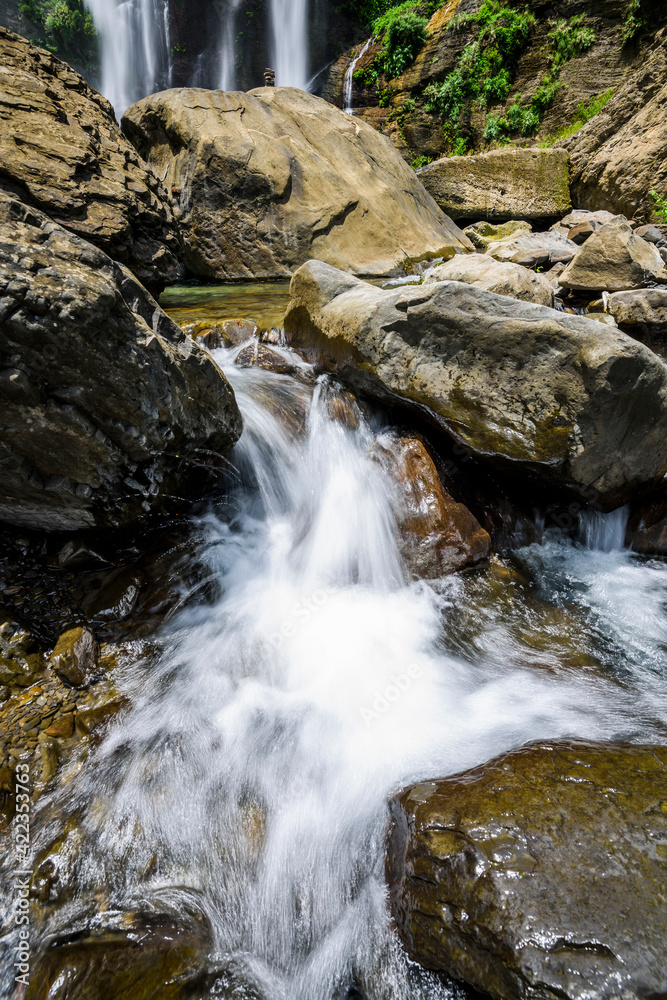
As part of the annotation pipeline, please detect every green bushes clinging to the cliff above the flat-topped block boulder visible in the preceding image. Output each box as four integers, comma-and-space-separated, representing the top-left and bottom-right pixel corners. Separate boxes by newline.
424, 0, 595, 150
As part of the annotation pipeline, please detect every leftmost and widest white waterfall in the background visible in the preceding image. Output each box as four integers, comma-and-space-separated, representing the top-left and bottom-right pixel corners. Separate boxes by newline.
84, 0, 171, 118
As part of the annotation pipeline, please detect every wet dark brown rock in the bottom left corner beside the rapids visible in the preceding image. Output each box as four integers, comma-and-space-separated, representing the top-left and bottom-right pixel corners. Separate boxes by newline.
24, 913, 210, 1000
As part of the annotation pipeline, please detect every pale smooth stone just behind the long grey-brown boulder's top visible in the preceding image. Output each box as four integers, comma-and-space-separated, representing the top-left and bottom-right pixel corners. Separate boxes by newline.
424, 254, 554, 306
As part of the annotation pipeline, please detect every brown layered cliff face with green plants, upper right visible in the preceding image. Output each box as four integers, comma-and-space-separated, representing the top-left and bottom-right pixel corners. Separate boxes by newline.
325, 0, 667, 212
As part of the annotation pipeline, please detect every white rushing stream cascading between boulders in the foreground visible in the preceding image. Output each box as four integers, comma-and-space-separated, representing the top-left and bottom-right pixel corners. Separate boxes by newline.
5, 326, 667, 1000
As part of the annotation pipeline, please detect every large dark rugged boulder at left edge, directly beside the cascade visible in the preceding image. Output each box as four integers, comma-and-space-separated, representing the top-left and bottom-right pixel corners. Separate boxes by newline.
0, 188, 241, 531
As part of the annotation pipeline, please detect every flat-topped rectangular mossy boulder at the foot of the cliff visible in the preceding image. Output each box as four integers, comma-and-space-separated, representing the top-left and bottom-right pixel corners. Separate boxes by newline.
417, 147, 571, 222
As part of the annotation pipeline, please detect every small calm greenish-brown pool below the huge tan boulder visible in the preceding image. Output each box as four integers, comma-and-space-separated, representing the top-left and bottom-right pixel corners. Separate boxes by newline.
160, 281, 289, 332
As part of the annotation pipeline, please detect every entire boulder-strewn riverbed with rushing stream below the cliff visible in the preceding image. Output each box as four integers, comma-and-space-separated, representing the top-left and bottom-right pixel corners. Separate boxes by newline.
0, 13, 667, 1000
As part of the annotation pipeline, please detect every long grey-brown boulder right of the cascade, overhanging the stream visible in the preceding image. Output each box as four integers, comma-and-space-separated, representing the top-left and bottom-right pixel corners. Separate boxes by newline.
285, 261, 667, 509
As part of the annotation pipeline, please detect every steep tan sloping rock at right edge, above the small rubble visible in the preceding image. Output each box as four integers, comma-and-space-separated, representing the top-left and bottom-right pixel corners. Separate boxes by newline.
562, 27, 667, 222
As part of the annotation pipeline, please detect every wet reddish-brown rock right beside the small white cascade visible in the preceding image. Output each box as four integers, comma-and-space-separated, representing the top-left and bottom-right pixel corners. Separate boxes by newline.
376, 437, 491, 580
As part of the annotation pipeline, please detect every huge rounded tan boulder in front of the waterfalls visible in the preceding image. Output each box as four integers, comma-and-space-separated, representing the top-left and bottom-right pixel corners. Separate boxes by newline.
123, 87, 472, 280
